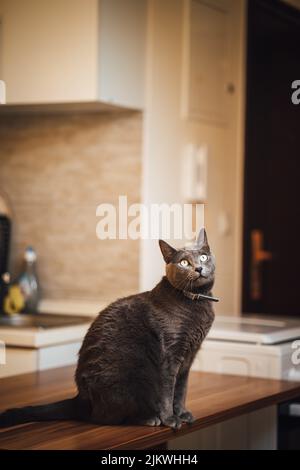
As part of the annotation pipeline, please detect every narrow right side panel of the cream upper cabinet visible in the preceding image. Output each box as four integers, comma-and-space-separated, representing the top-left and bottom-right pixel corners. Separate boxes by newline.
99, 0, 147, 109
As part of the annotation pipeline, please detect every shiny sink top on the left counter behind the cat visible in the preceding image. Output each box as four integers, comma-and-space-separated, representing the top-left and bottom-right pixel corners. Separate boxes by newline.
0, 313, 93, 330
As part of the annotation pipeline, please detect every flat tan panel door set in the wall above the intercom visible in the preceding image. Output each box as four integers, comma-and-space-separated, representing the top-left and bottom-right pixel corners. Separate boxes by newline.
183, 0, 234, 124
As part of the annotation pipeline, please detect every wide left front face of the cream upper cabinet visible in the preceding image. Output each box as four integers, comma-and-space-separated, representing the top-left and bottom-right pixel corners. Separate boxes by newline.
0, 0, 98, 104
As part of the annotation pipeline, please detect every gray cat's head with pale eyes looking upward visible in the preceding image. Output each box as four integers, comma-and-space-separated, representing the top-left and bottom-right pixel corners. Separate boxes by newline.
159, 228, 215, 293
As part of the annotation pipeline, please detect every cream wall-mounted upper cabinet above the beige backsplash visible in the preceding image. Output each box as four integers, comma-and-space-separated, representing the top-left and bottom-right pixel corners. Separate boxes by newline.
0, 0, 147, 109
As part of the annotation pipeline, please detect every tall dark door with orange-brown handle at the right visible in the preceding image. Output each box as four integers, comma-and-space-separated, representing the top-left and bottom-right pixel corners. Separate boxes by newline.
243, 0, 300, 318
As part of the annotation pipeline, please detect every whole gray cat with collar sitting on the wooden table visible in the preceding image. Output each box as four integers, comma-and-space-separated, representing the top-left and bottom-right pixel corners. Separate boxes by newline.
0, 229, 216, 428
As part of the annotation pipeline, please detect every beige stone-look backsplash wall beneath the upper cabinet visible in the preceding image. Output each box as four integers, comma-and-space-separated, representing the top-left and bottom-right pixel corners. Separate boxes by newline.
0, 113, 142, 300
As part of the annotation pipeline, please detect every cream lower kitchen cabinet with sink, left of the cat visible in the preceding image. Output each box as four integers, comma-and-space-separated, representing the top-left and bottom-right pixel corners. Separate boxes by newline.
0, 313, 93, 377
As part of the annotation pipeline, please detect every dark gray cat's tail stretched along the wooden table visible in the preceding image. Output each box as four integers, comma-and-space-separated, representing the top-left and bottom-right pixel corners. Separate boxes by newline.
0, 395, 90, 428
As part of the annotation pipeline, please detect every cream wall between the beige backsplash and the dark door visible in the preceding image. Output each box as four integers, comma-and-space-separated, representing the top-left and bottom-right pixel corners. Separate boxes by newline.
140, 0, 245, 314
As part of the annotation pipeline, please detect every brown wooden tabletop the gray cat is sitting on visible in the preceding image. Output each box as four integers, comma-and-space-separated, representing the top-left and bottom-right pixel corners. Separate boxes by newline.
0, 367, 300, 450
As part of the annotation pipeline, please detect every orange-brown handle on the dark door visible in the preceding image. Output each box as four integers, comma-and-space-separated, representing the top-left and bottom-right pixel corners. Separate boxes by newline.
250, 229, 273, 300
